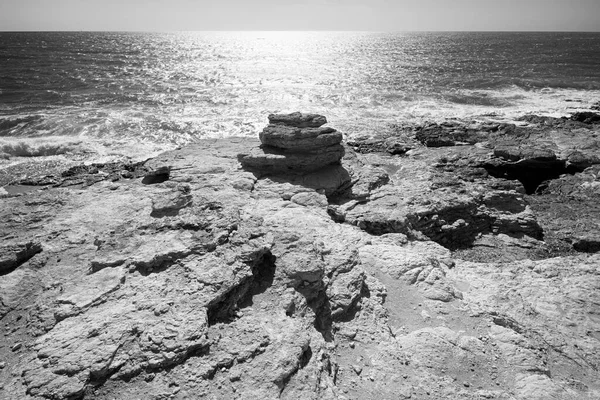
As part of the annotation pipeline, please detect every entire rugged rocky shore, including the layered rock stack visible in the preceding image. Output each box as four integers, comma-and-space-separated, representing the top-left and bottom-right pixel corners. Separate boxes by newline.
0, 113, 600, 400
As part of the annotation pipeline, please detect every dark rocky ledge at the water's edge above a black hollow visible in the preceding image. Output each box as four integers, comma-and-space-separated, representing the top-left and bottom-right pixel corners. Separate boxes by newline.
415, 112, 600, 194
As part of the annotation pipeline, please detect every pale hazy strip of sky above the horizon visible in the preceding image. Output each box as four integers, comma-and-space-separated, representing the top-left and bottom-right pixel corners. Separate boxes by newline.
0, 0, 600, 31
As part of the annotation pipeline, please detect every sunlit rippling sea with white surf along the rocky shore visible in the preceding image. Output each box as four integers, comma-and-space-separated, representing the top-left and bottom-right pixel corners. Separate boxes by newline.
0, 32, 600, 164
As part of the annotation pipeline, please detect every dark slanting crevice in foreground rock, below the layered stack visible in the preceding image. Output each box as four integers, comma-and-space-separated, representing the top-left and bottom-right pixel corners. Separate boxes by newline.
207, 251, 276, 325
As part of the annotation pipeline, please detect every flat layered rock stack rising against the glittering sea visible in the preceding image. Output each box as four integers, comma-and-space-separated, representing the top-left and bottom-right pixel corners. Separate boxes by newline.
238, 112, 344, 174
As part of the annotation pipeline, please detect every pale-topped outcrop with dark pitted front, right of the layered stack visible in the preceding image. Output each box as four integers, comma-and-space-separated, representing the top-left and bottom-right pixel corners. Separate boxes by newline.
329, 148, 543, 250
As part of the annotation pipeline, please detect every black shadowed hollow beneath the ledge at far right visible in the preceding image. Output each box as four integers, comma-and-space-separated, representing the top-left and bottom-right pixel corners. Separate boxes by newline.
483, 160, 583, 194
